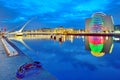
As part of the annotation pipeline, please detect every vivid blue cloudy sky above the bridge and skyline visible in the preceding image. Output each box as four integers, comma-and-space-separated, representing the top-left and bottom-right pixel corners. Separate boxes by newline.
0, 0, 120, 29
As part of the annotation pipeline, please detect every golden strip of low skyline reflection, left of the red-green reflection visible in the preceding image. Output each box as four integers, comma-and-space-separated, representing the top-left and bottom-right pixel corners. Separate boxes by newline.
8, 35, 75, 44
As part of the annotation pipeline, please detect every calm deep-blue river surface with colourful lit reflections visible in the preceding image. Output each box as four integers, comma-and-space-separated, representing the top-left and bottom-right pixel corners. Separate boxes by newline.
11, 36, 120, 80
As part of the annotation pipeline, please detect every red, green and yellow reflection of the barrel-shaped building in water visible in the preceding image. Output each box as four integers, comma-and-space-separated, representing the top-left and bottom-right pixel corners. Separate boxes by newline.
85, 36, 113, 57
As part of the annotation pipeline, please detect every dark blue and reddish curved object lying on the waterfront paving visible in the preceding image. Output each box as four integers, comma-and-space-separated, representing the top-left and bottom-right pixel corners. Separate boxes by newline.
16, 61, 42, 79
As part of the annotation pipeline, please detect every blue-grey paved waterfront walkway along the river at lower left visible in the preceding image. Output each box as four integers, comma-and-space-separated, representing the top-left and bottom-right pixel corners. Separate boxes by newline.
0, 37, 56, 80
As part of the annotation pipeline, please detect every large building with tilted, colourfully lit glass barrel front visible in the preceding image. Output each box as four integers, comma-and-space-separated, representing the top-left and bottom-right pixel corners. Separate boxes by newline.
85, 12, 114, 32
